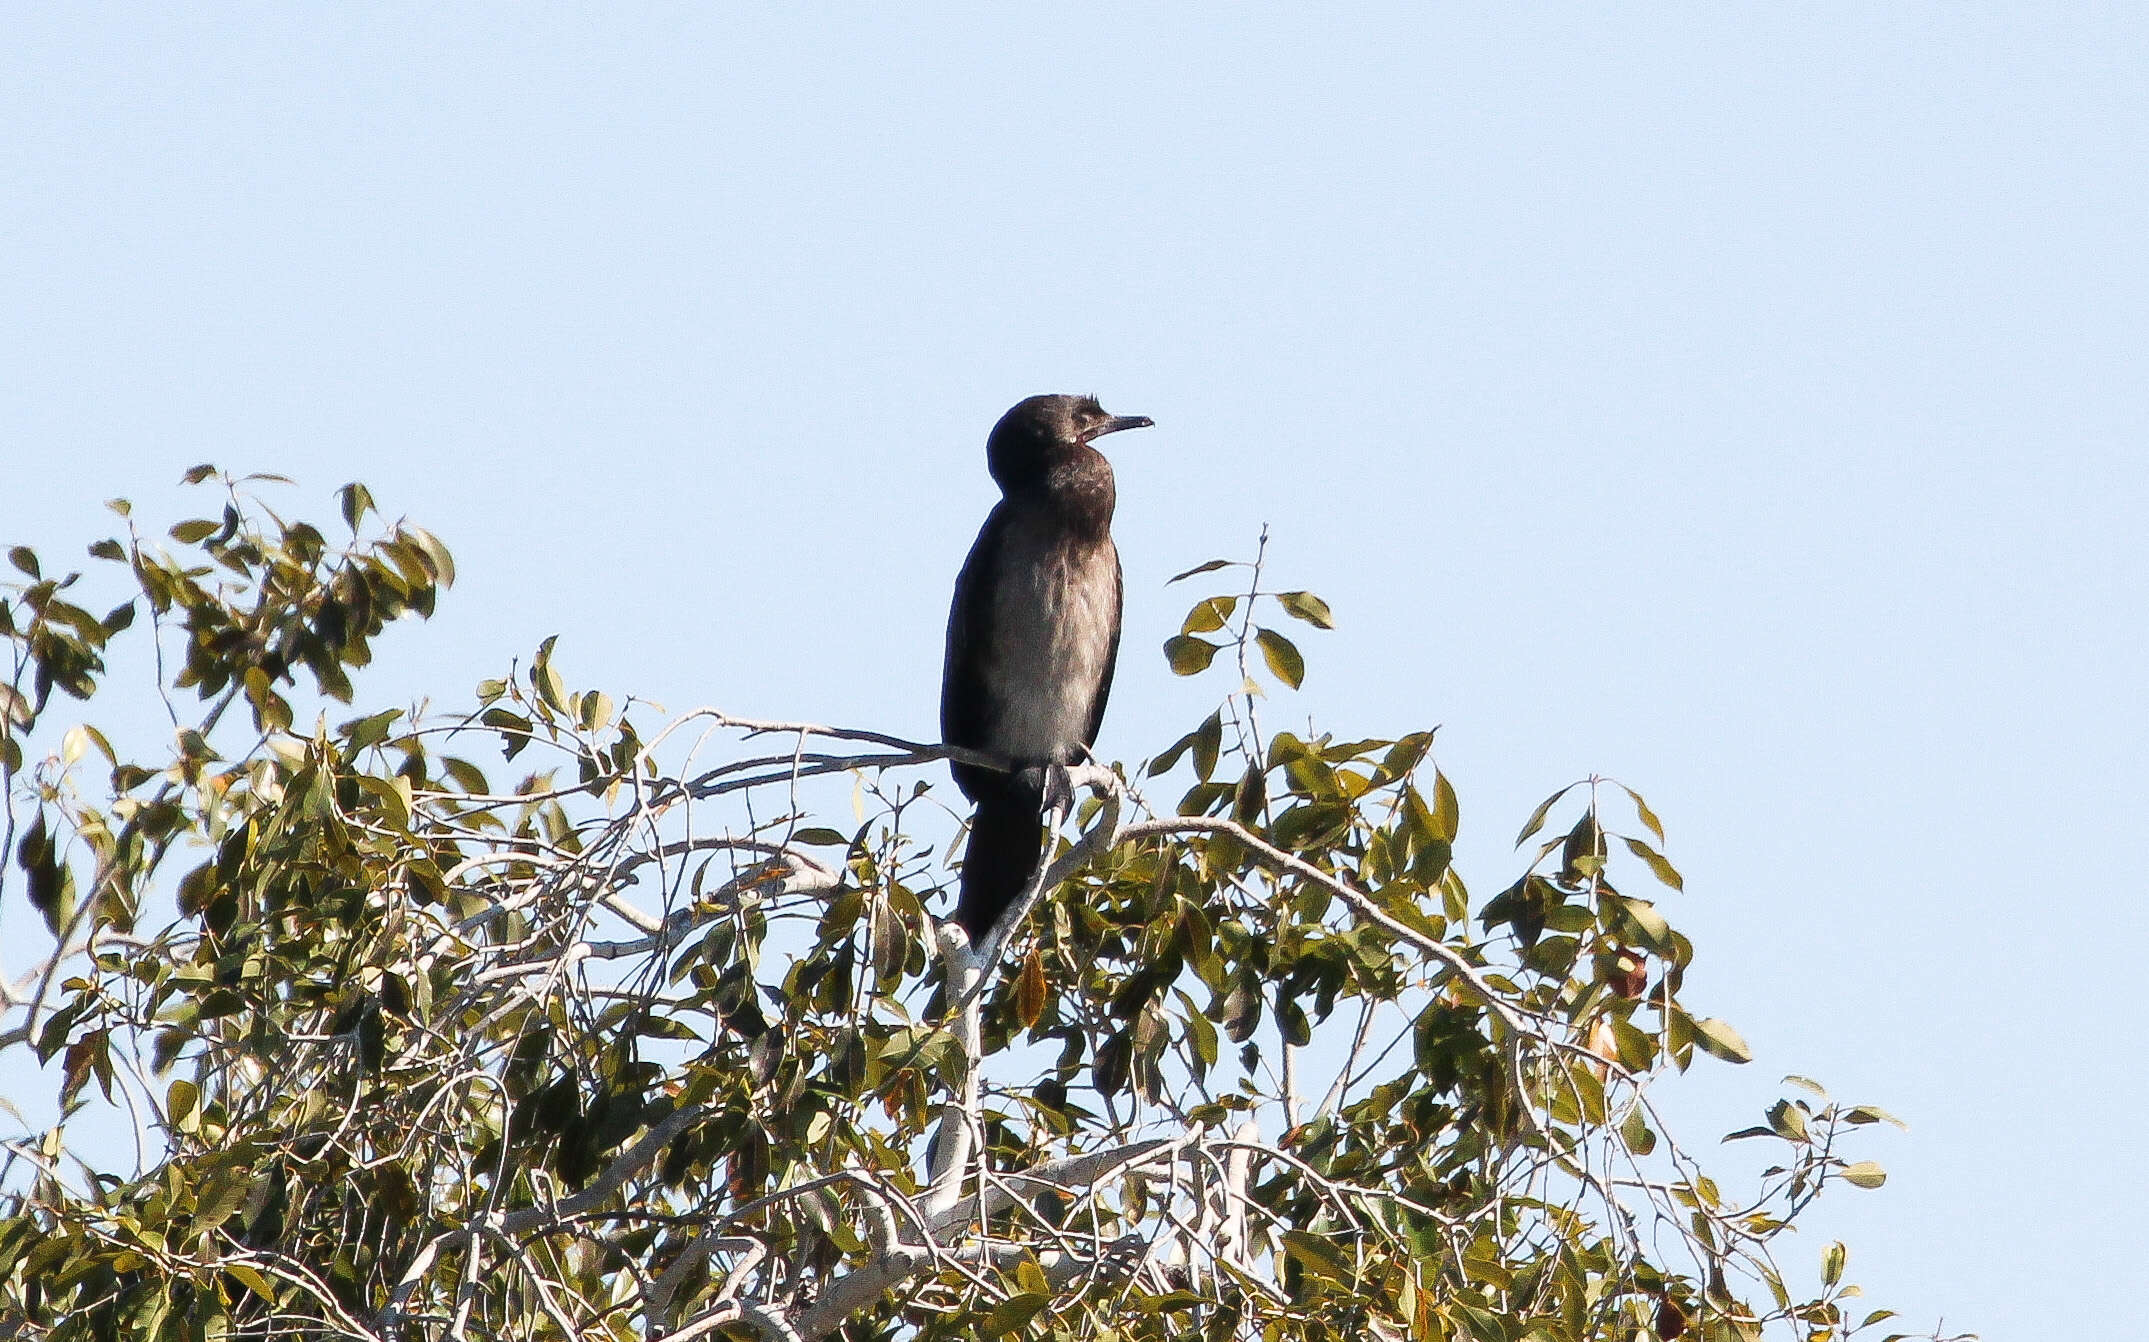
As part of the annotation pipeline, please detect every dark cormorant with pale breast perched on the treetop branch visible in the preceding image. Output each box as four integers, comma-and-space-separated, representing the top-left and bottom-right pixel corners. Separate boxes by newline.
941, 396, 1150, 944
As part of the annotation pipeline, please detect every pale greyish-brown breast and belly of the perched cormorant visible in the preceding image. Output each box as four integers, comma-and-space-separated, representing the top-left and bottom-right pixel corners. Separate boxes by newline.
989, 531, 1120, 761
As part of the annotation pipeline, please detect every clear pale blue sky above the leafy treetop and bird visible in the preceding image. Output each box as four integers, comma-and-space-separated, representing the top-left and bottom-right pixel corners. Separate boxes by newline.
0, 4, 2149, 1338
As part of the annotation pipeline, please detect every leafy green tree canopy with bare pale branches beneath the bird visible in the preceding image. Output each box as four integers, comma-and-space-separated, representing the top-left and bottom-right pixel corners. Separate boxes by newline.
0, 477, 1951, 1342
